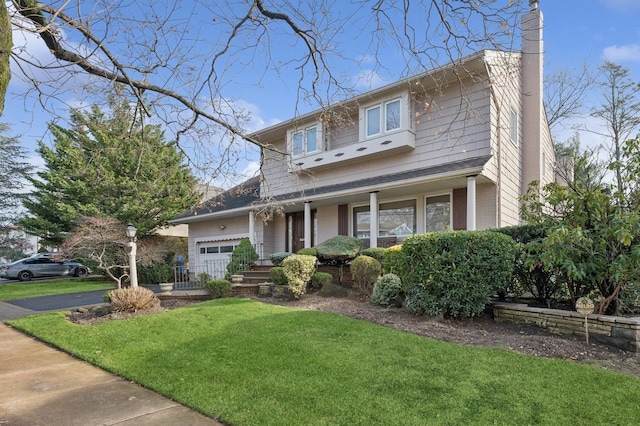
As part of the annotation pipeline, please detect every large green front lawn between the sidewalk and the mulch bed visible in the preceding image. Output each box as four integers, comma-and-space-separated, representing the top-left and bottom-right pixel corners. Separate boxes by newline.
9, 299, 640, 425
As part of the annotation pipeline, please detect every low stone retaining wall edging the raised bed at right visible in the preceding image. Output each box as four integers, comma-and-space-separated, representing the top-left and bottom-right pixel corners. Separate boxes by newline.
492, 302, 640, 353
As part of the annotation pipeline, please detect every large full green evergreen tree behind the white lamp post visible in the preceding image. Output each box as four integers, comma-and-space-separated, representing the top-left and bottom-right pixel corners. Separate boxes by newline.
22, 94, 197, 245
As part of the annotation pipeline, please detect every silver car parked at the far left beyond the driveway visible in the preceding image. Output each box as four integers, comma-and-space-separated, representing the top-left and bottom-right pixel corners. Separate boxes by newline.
0, 254, 91, 281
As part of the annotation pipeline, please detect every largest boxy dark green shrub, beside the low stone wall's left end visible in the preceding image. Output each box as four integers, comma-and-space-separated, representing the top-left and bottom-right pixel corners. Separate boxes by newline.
399, 231, 516, 317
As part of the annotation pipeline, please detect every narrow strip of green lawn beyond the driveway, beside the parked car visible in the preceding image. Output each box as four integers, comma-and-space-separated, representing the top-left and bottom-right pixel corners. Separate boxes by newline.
0, 278, 115, 300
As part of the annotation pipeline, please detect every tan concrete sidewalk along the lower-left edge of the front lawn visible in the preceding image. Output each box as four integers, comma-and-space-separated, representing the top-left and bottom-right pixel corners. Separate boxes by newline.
0, 322, 221, 426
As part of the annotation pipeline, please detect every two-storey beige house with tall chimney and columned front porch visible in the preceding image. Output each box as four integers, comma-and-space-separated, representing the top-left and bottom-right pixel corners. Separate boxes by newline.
173, 2, 555, 278
